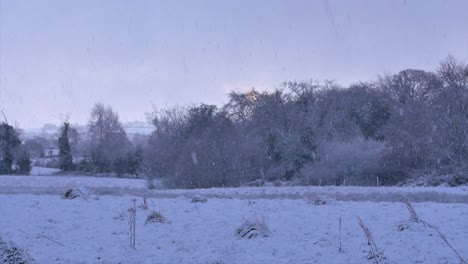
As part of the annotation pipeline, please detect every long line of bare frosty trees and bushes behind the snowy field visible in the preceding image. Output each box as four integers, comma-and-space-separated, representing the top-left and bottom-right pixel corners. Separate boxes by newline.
1, 57, 468, 188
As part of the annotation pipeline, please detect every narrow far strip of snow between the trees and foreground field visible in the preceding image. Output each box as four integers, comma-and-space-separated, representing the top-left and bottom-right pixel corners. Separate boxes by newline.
0, 176, 468, 203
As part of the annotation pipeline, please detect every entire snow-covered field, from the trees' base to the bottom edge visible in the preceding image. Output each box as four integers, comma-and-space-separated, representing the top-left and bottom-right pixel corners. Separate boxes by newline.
0, 176, 468, 263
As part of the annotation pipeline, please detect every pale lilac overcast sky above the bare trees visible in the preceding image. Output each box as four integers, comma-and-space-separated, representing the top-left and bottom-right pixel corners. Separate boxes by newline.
0, 0, 468, 128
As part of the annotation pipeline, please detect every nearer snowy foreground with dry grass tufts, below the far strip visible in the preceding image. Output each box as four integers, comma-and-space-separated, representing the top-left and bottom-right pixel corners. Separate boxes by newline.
0, 195, 468, 263
